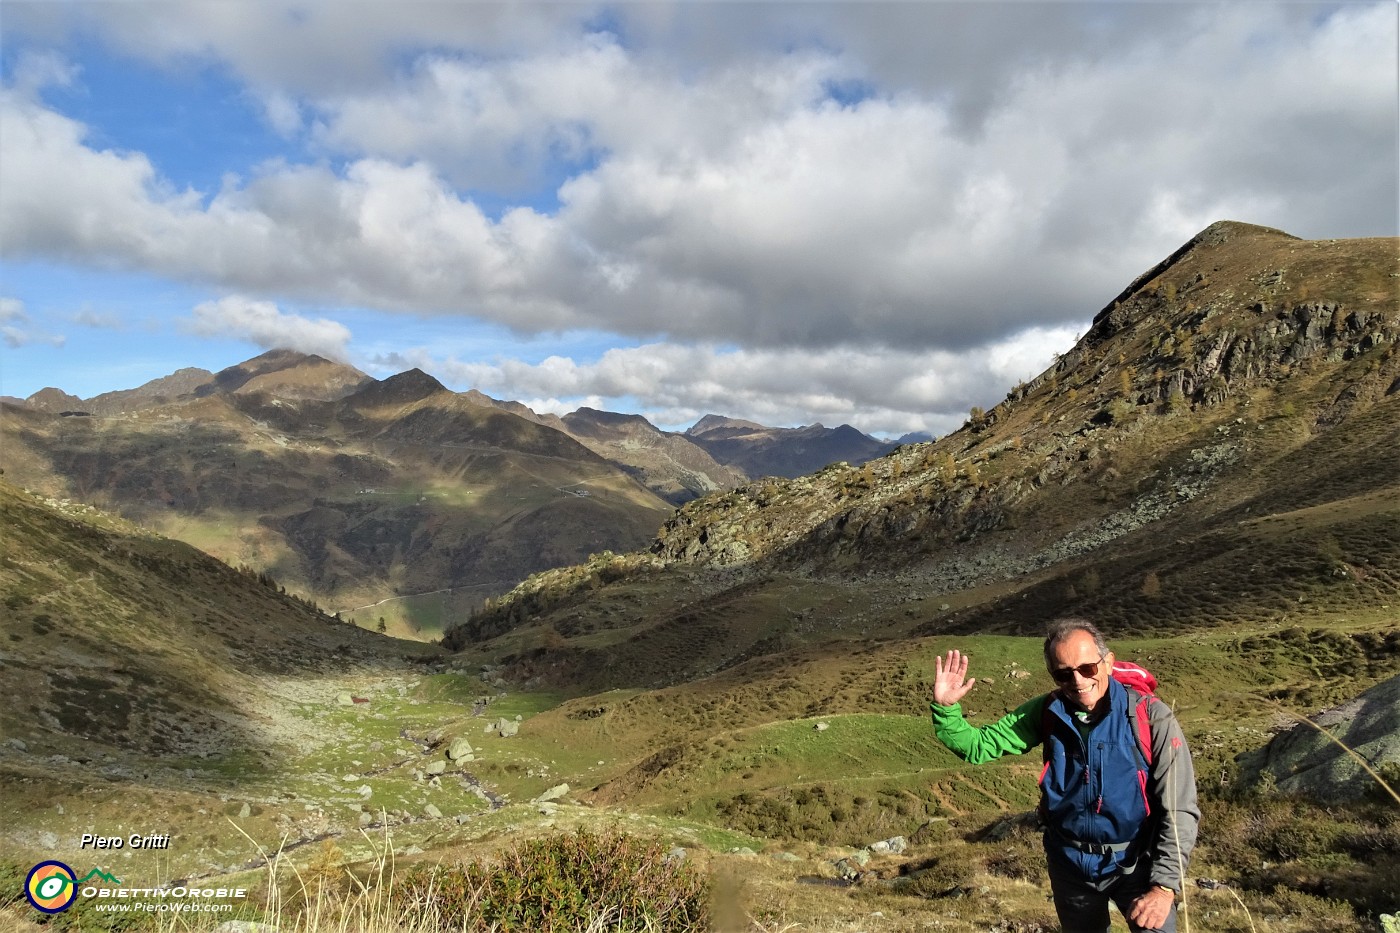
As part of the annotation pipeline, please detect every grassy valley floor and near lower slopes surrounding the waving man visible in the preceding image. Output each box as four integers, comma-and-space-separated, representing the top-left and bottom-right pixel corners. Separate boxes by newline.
0, 486, 1400, 933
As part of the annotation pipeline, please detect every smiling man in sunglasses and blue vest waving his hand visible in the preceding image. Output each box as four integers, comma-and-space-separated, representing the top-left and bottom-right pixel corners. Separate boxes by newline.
930, 619, 1201, 933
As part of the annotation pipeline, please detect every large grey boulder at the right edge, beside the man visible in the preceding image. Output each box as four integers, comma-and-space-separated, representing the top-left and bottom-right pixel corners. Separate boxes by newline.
1238, 675, 1400, 803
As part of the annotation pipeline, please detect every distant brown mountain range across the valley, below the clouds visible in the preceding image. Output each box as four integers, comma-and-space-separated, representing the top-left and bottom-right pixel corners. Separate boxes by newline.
0, 350, 890, 636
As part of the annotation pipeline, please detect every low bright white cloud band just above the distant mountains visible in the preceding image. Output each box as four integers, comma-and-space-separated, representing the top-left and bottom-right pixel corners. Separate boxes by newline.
372, 328, 1075, 434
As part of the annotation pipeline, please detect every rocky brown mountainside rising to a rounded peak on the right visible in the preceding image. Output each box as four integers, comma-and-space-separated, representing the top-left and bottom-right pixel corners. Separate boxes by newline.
447, 221, 1400, 680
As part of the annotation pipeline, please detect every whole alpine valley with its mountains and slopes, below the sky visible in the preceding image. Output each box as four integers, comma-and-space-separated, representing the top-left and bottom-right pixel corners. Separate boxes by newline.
0, 221, 1400, 933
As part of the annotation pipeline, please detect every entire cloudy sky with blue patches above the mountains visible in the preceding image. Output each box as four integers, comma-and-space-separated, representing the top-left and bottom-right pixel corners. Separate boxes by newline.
0, 0, 1400, 437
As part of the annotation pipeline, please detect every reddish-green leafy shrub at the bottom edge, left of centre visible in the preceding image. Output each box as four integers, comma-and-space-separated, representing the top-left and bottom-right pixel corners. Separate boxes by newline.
395, 829, 710, 933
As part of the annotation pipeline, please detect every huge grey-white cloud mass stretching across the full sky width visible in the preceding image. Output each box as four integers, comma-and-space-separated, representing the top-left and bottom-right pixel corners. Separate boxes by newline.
0, 6, 1396, 357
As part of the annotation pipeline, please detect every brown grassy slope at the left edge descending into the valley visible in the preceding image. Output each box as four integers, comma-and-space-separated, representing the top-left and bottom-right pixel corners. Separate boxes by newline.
0, 481, 431, 765
